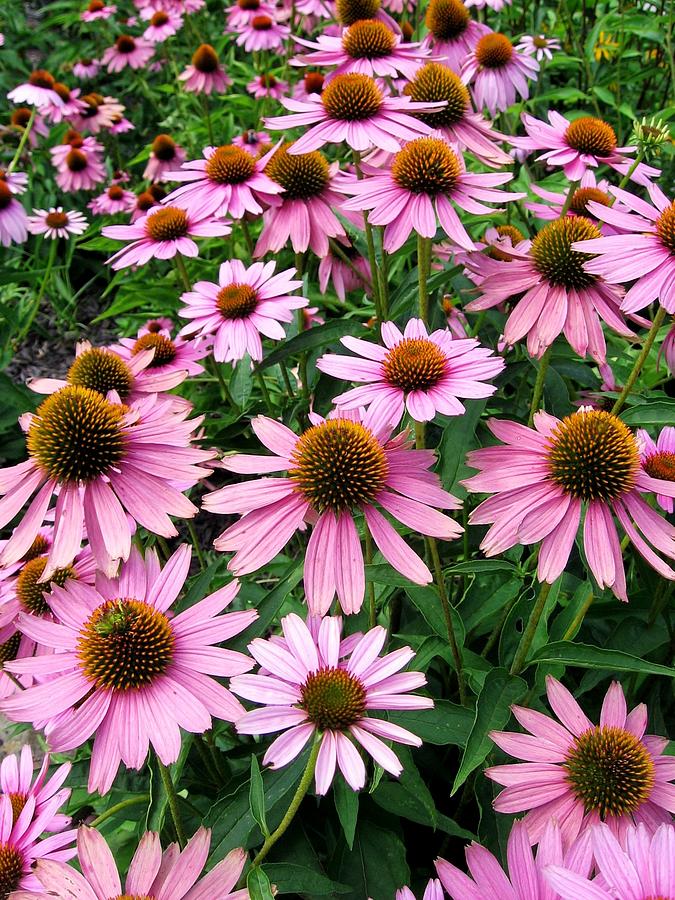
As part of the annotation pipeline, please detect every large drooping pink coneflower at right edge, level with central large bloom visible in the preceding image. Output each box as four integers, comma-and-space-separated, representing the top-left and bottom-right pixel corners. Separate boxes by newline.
463, 407, 675, 600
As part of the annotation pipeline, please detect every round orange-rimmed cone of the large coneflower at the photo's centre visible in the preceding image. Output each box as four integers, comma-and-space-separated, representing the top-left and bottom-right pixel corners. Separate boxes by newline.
288, 419, 389, 514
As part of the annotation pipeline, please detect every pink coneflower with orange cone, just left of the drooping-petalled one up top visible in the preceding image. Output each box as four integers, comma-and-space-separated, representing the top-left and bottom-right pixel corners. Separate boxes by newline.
163, 144, 283, 219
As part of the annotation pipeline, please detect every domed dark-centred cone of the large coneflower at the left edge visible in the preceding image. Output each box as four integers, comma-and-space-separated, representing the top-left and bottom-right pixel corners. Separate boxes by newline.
26, 385, 126, 484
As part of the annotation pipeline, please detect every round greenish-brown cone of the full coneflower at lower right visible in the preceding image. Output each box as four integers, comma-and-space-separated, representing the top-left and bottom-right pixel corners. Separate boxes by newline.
563, 725, 655, 819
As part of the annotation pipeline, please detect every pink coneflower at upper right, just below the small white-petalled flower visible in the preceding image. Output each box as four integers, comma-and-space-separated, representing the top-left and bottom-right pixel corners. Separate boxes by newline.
510, 110, 661, 186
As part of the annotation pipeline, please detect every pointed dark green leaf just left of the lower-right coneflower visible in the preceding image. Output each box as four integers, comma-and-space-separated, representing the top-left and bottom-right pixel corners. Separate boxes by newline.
450, 669, 527, 795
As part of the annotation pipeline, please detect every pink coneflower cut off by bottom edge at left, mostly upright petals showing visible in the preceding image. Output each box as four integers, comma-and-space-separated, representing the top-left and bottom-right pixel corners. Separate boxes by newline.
26, 826, 248, 900
